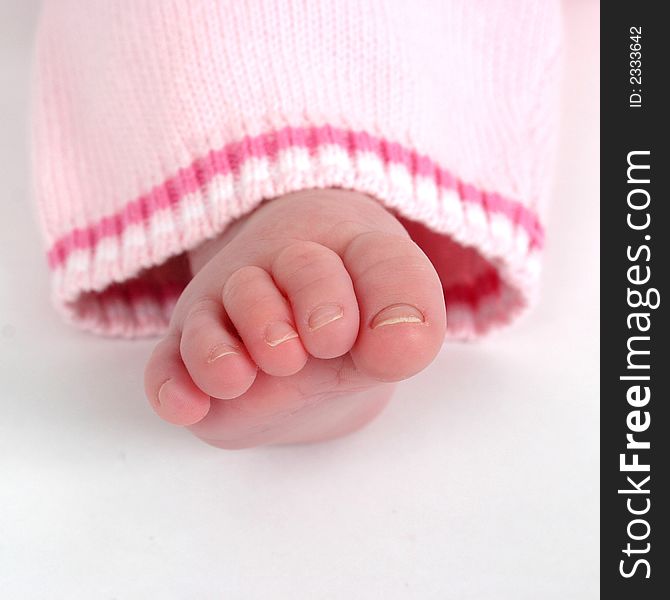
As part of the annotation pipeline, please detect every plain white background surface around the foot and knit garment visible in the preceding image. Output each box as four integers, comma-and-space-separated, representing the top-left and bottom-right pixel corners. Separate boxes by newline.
0, 0, 599, 600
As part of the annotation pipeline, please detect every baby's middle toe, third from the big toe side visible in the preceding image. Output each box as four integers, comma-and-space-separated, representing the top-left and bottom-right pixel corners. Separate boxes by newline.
223, 266, 307, 376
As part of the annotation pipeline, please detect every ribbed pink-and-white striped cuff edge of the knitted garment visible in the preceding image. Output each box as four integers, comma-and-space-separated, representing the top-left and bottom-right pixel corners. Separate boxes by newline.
48, 126, 544, 338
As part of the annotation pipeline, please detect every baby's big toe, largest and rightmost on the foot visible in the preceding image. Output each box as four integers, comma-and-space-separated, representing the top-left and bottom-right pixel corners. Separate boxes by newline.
343, 232, 446, 381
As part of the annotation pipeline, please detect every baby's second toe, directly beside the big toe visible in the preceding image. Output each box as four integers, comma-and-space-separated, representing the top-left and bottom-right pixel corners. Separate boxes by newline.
272, 242, 359, 359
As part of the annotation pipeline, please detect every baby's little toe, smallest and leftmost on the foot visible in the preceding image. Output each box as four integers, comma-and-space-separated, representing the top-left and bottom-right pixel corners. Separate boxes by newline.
144, 333, 210, 425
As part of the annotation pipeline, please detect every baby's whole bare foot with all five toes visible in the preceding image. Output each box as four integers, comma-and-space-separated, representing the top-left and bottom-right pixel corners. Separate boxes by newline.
145, 189, 446, 448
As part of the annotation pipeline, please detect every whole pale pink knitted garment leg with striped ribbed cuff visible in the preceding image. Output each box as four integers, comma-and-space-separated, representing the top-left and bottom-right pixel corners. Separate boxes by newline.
33, 0, 561, 338
